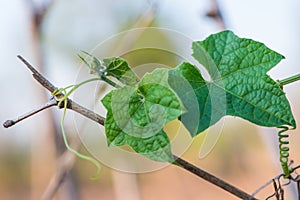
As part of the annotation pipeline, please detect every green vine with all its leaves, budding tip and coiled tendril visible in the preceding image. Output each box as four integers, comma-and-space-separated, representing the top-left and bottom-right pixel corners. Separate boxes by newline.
75, 31, 296, 177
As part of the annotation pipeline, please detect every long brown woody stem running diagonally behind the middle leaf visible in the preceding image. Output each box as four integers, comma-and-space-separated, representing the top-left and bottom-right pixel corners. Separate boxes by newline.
3, 55, 256, 200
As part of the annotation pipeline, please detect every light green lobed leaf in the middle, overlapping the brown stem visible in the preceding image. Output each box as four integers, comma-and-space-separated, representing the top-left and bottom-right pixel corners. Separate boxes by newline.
102, 69, 184, 162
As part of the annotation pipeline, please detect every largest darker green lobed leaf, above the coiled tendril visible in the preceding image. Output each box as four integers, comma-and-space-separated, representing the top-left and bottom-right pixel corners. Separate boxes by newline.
169, 31, 296, 136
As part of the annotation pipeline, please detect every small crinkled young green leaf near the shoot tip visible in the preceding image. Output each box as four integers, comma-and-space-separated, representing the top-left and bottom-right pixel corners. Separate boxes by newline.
103, 57, 139, 86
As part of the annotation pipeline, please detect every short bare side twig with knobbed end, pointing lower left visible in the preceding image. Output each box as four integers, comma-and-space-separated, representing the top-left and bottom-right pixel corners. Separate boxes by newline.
3, 98, 57, 128
